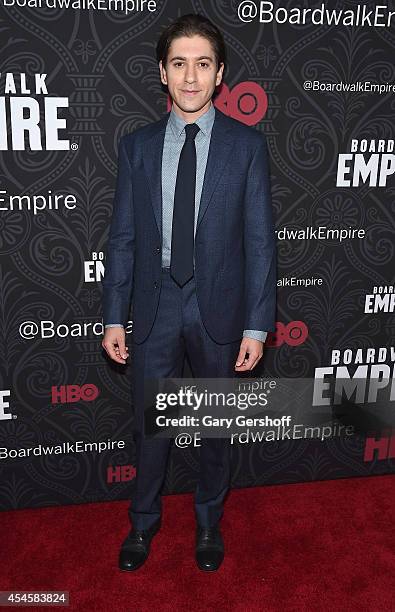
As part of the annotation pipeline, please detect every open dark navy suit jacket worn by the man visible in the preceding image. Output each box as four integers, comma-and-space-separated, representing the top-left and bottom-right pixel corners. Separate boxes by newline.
102, 108, 277, 344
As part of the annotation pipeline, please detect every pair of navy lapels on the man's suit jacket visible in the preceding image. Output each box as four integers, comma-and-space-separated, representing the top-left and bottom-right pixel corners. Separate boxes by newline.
143, 108, 232, 240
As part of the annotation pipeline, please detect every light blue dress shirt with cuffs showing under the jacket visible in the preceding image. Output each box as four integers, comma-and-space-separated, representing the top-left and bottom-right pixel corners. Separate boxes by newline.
106, 103, 267, 342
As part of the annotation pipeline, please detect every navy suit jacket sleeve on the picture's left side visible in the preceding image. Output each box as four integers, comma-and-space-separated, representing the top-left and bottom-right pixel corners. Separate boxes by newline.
102, 136, 135, 325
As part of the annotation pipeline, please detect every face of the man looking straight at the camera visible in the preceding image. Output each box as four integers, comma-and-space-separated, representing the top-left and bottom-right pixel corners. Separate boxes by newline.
159, 35, 224, 121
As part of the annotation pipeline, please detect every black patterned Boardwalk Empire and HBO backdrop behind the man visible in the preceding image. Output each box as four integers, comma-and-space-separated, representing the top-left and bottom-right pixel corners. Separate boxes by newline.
0, 0, 395, 510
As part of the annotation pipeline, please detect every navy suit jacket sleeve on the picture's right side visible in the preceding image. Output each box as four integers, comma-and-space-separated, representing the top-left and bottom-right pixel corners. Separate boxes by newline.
244, 134, 277, 331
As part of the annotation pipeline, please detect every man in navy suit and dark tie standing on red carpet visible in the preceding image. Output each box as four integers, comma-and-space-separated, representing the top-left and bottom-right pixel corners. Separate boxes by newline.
102, 15, 276, 571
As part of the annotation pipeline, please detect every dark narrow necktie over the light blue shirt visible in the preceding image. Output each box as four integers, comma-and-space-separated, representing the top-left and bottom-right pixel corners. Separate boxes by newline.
170, 123, 200, 287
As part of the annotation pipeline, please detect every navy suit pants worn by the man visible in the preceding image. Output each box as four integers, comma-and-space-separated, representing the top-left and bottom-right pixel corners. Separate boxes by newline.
129, 268, 242, 529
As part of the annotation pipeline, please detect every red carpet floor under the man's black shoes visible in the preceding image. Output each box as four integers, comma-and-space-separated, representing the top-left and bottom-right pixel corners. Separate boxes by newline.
0, 476, 395, 612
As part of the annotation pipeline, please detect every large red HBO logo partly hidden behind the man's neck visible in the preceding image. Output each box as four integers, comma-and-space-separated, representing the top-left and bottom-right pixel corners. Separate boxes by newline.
167, 81, 268, 125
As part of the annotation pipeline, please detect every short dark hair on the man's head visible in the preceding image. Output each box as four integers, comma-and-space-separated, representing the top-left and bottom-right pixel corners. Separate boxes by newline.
156, 13, 226, 72
